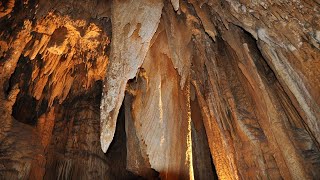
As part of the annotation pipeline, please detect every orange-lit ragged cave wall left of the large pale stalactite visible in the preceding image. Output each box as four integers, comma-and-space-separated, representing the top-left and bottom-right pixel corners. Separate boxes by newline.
0, 1, 111, 179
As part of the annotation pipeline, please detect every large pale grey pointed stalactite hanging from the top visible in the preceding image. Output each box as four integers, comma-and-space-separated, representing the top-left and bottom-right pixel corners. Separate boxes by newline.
100, 0, 163, 152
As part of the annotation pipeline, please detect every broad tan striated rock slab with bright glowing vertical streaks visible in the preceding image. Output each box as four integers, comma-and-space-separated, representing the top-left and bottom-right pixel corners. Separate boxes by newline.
128, 21, 193, 179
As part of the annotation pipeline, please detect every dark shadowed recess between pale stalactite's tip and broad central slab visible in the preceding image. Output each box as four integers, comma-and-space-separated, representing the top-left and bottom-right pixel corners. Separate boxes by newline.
105, 90, 160, 179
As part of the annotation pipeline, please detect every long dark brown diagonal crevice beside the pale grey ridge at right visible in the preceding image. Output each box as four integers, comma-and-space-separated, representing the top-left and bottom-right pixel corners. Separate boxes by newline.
232, 26, 320, 170
